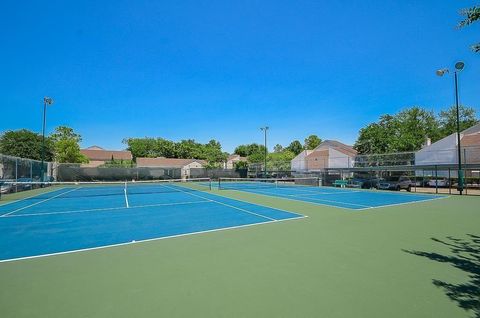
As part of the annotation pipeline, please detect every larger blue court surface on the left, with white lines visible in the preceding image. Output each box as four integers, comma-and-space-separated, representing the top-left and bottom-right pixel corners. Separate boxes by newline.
0, 185, 303, 261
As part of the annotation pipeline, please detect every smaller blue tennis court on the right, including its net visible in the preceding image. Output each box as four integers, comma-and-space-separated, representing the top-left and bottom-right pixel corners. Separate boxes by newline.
218, 178, 447, 210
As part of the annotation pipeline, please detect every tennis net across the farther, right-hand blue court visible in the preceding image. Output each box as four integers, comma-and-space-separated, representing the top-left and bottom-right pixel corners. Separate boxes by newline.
218, 177, 320, 190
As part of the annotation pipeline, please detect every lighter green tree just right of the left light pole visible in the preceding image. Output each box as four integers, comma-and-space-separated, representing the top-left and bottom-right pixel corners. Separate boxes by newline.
49, 126, 88, 163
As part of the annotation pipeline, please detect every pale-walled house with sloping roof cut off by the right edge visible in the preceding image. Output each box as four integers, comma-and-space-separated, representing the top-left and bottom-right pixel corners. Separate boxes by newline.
415, 123, 480, 166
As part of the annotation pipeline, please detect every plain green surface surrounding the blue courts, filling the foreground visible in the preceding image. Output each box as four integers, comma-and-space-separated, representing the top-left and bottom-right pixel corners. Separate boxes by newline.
0, 190, 480, 318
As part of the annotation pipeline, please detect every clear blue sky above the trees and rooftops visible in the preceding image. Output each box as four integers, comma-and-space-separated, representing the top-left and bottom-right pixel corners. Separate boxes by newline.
0, 0, 480, 151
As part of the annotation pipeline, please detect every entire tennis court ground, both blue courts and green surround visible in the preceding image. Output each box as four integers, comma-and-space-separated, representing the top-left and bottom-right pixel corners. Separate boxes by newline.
0, 179, 479, 318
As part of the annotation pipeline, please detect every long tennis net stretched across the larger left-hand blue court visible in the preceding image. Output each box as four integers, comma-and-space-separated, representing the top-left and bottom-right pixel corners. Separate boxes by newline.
0, 178, 211, 199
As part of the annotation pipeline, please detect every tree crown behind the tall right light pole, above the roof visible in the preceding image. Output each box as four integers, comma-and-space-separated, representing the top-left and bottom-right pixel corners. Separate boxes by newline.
438, 105, 479, 138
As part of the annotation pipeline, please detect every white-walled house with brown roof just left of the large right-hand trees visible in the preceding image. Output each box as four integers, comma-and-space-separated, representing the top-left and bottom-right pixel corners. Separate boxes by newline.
291, 140, 357, 171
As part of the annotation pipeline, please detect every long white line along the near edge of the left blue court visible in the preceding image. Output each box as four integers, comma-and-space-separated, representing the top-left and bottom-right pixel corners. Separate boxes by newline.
0, 216, 304, 263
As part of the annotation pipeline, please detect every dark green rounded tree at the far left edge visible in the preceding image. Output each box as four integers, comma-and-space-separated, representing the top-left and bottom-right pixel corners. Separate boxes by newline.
0, 129, 54, 161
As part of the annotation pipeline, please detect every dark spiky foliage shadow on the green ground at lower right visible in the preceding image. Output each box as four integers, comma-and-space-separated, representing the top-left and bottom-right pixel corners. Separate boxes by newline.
403, 234, 480, 318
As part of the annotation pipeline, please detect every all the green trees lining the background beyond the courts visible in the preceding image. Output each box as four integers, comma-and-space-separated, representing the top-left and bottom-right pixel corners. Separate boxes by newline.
0, 106, 479, 165
